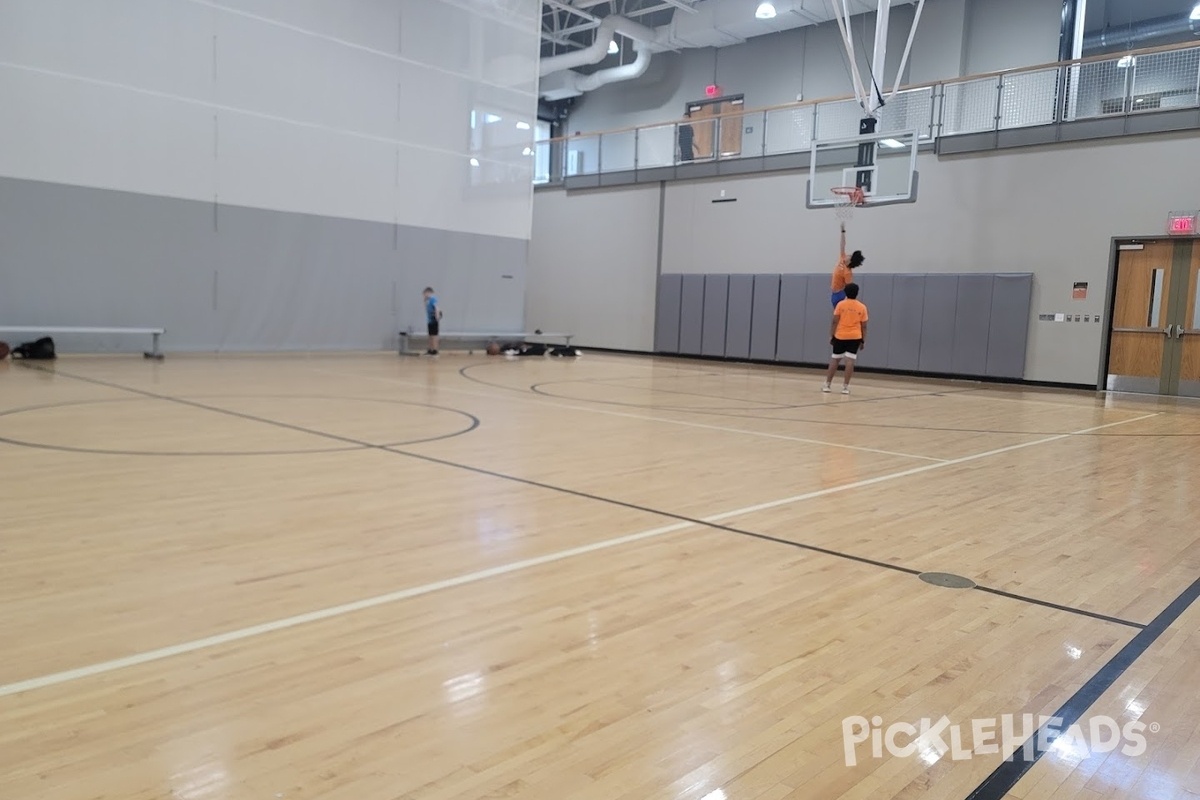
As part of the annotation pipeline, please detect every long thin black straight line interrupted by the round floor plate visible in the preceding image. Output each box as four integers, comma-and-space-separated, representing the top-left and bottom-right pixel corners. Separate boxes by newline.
16, 366, 1145, 628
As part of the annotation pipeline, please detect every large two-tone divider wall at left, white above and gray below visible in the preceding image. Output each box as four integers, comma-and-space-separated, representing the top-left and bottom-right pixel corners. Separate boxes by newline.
0, 0, 539, 349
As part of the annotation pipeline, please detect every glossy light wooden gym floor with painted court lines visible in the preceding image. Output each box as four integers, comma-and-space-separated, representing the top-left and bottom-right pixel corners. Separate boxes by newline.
0, 354, 1200, 800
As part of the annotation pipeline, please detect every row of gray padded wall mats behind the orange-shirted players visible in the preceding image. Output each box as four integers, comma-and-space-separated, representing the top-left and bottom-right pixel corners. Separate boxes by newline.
655, 272, 1033, 378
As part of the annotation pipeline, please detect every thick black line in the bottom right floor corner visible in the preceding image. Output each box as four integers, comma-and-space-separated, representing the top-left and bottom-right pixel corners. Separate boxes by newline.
966, 578, 1200, 800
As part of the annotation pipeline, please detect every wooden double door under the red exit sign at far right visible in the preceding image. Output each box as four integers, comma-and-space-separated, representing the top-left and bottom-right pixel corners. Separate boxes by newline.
1108, 239, 1200, 397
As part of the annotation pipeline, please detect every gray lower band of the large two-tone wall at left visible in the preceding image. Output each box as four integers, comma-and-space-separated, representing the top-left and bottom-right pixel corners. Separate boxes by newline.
0, 179, 528, 351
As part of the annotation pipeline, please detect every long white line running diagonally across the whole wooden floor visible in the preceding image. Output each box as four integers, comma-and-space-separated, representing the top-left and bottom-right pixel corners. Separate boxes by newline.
0, 413, 1159, 697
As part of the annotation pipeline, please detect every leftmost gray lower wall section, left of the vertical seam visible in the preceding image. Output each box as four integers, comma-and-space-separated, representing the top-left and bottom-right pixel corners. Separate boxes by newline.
0, 179, 217, 353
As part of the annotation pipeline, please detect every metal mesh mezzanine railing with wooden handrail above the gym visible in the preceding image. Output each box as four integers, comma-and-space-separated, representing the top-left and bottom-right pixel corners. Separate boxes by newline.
534, 43, 1200, 184
